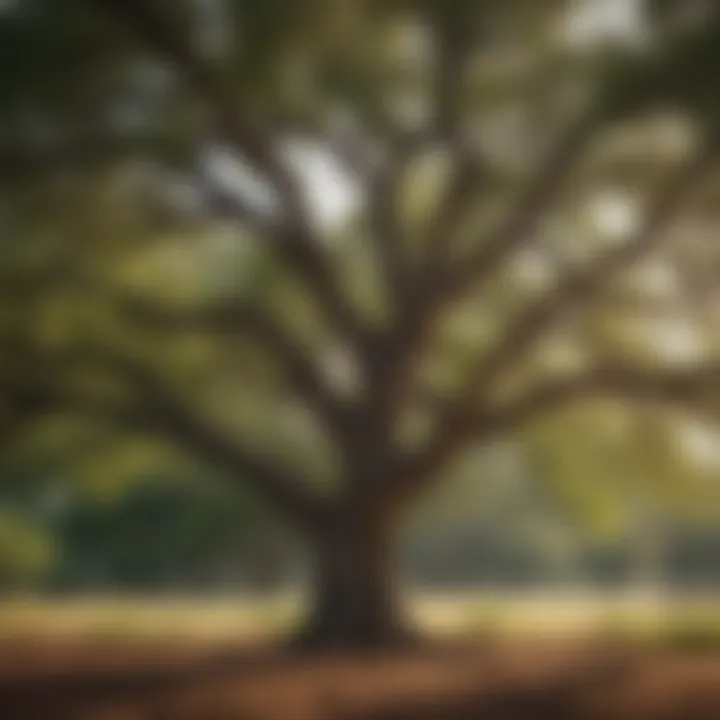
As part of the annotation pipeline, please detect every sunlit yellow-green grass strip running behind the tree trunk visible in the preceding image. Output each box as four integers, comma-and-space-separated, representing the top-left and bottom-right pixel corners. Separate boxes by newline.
0, 592, 720, 649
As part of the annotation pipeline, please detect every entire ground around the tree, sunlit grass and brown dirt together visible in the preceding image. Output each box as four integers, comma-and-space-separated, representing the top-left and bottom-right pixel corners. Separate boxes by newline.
0, 593, 720, 720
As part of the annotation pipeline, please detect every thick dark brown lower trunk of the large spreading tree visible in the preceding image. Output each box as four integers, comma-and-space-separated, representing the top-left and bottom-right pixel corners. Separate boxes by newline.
299, 506, 409, 649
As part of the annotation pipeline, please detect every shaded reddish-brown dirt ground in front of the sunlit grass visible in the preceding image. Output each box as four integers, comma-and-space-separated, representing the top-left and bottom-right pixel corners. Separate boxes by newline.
0, 638, 720, 720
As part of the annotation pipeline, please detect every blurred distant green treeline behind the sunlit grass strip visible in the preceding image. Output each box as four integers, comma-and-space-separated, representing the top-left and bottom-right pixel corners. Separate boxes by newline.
0, 483, 720, 592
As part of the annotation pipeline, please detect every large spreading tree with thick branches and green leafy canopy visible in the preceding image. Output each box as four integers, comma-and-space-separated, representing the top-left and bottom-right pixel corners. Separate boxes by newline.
2, 0, 720, 646
